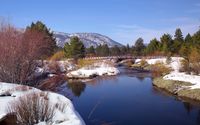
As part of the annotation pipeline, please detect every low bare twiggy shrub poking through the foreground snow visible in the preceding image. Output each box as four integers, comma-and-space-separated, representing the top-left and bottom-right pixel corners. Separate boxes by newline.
7, 92, 55, 125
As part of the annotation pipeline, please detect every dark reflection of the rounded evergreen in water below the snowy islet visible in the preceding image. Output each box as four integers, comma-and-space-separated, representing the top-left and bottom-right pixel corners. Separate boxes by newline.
67, 81, 86, 97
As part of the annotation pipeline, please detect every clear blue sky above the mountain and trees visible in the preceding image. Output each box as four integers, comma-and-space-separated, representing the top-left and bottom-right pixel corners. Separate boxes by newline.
0, 0, 200, 45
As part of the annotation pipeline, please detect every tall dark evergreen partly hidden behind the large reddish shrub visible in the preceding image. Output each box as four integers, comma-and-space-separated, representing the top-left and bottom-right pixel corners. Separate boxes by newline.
25, 21, 57, 56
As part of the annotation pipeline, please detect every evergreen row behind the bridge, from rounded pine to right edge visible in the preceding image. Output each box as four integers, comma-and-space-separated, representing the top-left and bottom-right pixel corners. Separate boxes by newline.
64, 28, 200, 58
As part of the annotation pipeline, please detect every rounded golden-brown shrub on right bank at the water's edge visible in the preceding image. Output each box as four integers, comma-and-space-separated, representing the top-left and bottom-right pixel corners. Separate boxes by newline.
151, 62, 172, 77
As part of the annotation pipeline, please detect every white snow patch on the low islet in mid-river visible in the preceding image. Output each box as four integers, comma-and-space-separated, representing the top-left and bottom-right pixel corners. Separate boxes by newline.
67, 62, 119, 78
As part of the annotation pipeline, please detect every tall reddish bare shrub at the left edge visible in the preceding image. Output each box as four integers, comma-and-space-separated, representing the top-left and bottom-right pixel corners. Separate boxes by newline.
0, 23, 52, 84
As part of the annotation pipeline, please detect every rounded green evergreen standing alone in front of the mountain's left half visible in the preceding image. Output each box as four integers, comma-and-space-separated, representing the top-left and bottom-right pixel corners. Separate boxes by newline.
64, 37, 85, 59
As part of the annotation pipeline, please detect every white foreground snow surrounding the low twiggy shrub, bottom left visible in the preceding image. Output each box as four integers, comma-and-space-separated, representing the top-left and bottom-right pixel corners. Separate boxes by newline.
0, 82, 85, 125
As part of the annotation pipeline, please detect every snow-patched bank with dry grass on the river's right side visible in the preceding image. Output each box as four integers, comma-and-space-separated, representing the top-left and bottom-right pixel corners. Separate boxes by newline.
136, 57, 200, 101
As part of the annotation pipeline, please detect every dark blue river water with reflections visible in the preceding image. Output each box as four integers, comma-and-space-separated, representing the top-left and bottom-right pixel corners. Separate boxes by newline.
55, 69, 200, 125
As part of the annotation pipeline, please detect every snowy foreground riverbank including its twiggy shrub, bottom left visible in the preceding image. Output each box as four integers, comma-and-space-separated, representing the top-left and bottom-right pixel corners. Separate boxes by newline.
0, 82, 85, 125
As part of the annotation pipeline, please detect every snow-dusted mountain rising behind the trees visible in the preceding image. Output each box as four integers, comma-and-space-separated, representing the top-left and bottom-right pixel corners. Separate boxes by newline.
54, 32, 123, 48
